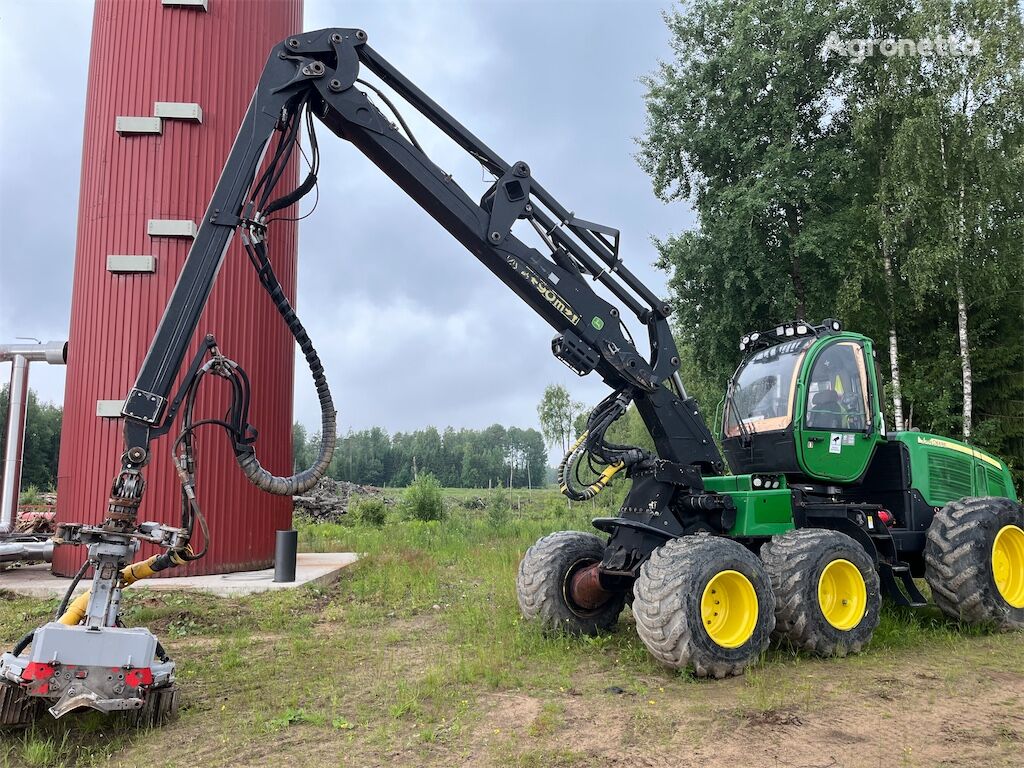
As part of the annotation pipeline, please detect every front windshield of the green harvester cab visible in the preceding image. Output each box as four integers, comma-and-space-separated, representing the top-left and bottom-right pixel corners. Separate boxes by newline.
725, 337, 814, 437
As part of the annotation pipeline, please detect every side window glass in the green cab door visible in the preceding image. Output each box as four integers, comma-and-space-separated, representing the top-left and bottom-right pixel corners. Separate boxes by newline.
805, 341, 867, 432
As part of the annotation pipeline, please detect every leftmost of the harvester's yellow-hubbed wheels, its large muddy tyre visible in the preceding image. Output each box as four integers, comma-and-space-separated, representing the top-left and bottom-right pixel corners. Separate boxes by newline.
633, 536, 775, 678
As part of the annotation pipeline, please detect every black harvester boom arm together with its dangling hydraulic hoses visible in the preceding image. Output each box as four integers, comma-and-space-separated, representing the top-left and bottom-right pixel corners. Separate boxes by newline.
96, 29, 722, 581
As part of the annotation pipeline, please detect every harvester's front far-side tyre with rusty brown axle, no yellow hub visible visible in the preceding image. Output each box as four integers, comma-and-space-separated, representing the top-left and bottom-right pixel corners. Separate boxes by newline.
515, 530, 626, 635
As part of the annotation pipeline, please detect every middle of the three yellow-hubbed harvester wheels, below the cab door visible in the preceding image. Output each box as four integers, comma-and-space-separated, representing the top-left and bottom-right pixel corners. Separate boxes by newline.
761, 528, 882, 656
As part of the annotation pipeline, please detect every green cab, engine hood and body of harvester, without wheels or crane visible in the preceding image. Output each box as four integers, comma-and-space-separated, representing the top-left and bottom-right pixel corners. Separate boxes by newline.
705, 319, 1017, 604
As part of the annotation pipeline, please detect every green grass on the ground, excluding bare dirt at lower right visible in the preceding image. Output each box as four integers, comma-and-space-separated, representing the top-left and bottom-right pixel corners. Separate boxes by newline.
0, 489, 1024, 766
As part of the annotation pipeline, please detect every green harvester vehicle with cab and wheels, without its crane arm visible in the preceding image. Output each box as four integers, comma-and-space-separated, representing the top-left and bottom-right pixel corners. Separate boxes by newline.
518, 319, 1024, 677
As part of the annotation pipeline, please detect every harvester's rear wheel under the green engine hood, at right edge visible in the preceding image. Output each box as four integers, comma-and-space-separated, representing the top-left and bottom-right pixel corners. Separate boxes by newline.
925, 497, 1024, 630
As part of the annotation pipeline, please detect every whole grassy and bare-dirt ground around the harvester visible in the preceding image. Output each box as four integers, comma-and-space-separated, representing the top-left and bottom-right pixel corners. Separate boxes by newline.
0, 489, 1024, 768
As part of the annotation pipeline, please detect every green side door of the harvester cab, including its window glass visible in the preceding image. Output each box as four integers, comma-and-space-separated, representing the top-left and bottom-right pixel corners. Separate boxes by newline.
794, 338, 881, 482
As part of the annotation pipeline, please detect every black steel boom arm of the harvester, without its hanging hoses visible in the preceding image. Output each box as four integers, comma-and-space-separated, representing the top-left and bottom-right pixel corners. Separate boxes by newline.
124, 29, 720, 468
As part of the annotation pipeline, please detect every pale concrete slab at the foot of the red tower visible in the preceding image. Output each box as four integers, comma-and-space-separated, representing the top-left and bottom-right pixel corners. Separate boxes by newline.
0, 552, 357, 597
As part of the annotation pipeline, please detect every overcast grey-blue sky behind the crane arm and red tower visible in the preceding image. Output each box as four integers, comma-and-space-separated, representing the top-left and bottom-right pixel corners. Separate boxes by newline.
0, 0, 693, 442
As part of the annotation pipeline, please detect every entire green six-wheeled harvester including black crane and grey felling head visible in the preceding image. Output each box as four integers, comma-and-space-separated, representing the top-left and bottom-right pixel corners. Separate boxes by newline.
0, 29, 1024, 725
